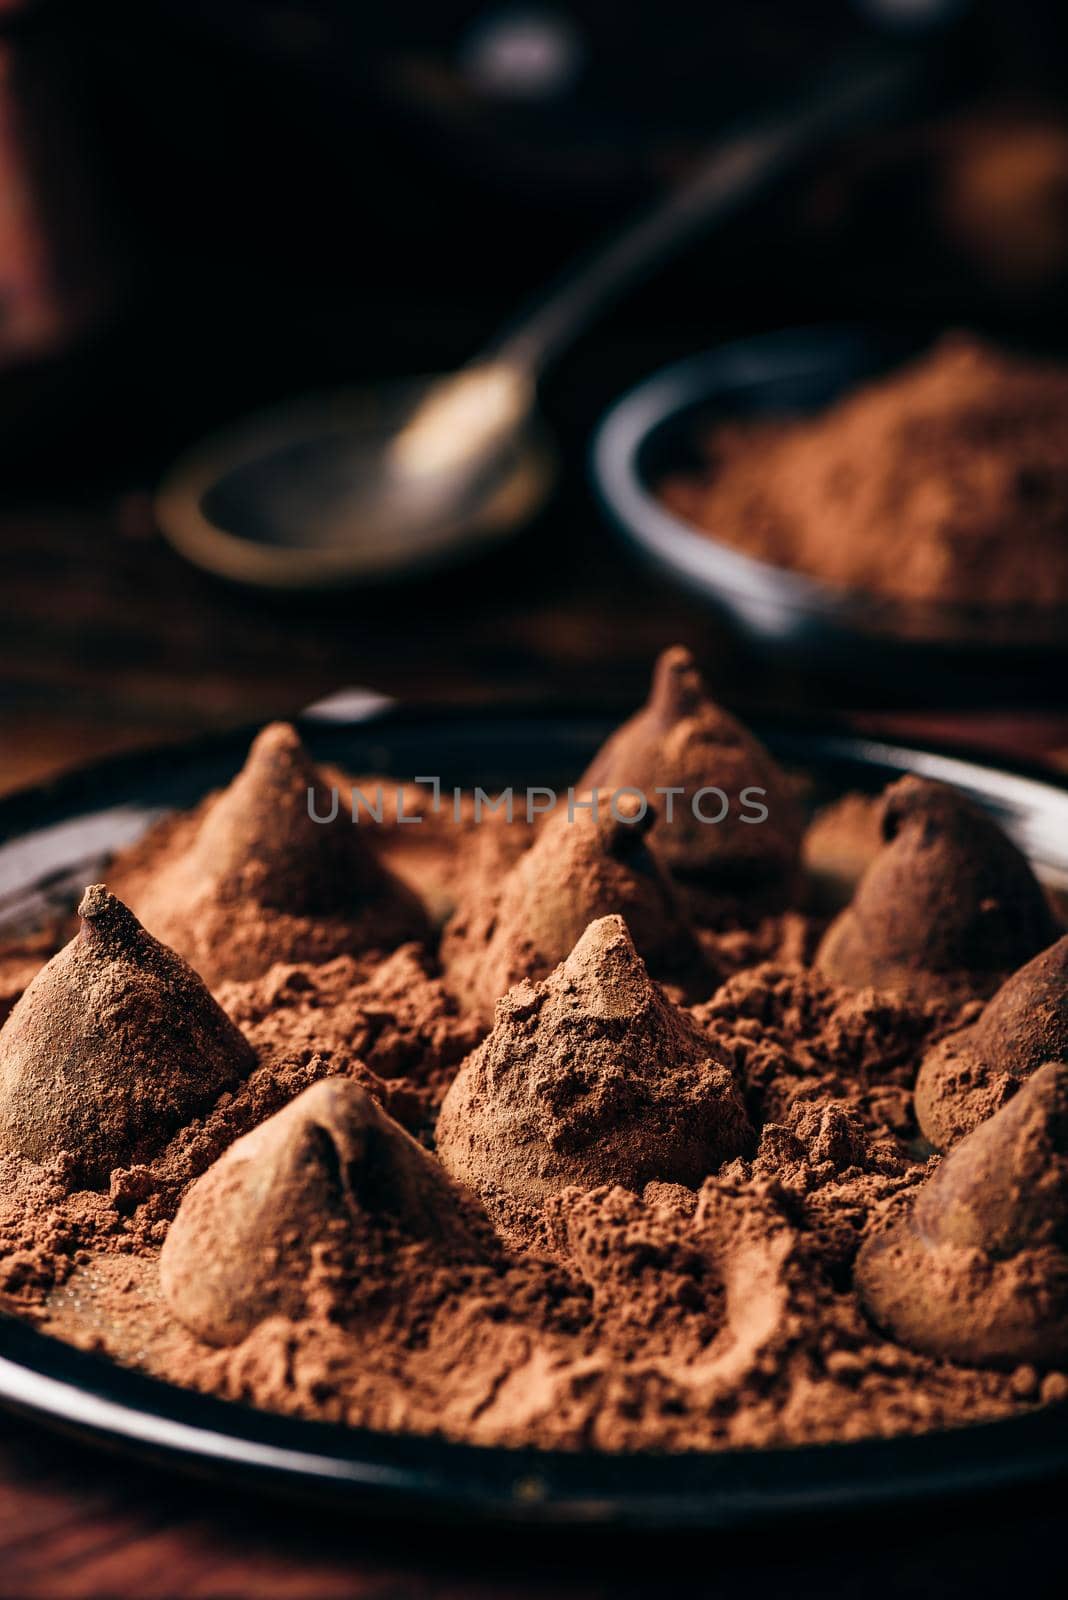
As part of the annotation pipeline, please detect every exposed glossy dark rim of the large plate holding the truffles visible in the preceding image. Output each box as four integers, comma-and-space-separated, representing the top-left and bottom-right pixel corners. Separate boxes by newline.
0, 709, 1068, 1528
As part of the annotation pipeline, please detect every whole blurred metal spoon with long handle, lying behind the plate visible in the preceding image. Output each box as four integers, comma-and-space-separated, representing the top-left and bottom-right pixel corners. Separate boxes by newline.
157, 51, 916, 587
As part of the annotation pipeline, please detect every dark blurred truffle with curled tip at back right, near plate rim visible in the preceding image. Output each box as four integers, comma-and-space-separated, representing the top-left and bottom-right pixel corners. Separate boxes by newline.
815, 778, 1058, 1000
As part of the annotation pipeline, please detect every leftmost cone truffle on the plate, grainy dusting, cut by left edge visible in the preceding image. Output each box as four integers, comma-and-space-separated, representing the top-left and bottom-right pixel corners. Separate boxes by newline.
0, 883, 256, 1184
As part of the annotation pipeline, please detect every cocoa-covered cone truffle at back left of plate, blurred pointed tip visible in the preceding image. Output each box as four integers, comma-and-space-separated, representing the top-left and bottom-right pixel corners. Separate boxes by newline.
123, 723, 427, 984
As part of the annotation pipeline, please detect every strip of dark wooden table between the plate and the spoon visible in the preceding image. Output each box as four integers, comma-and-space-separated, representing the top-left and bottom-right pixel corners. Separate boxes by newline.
0, 499, 1068, 794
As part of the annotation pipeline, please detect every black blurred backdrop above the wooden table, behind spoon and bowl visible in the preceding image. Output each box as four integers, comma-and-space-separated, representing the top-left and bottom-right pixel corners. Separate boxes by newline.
8, 0, 1068, 490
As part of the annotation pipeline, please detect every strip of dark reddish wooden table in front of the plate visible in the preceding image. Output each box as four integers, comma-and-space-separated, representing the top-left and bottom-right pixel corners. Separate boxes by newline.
0, 1419, 1065, 1600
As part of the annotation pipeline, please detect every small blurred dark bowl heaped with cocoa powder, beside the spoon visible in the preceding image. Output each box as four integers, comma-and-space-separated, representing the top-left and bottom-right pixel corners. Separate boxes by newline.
593, 328, 1068, 666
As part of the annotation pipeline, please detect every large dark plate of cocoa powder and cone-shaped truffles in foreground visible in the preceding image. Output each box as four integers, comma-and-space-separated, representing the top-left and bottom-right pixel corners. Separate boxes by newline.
0, 650, 1068, 1526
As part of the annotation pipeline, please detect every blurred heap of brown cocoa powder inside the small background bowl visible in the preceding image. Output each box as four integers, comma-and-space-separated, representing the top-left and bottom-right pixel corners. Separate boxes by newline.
660, 334, 1068, 610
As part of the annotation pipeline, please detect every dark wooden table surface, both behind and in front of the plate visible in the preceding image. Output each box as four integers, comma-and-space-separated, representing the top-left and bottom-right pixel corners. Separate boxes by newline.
0, 502, 1068, 1600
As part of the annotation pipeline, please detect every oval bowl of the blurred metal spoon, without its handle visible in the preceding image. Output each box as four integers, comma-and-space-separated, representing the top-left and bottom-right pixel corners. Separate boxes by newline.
157, 376, 556, 589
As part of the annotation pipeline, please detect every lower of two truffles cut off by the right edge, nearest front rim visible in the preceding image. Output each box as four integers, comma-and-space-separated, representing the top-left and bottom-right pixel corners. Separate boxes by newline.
855, 1062, 1068, 1366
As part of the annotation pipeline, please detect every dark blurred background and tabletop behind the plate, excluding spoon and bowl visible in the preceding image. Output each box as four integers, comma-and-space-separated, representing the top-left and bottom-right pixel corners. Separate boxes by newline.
0, 0, 1068, 787
